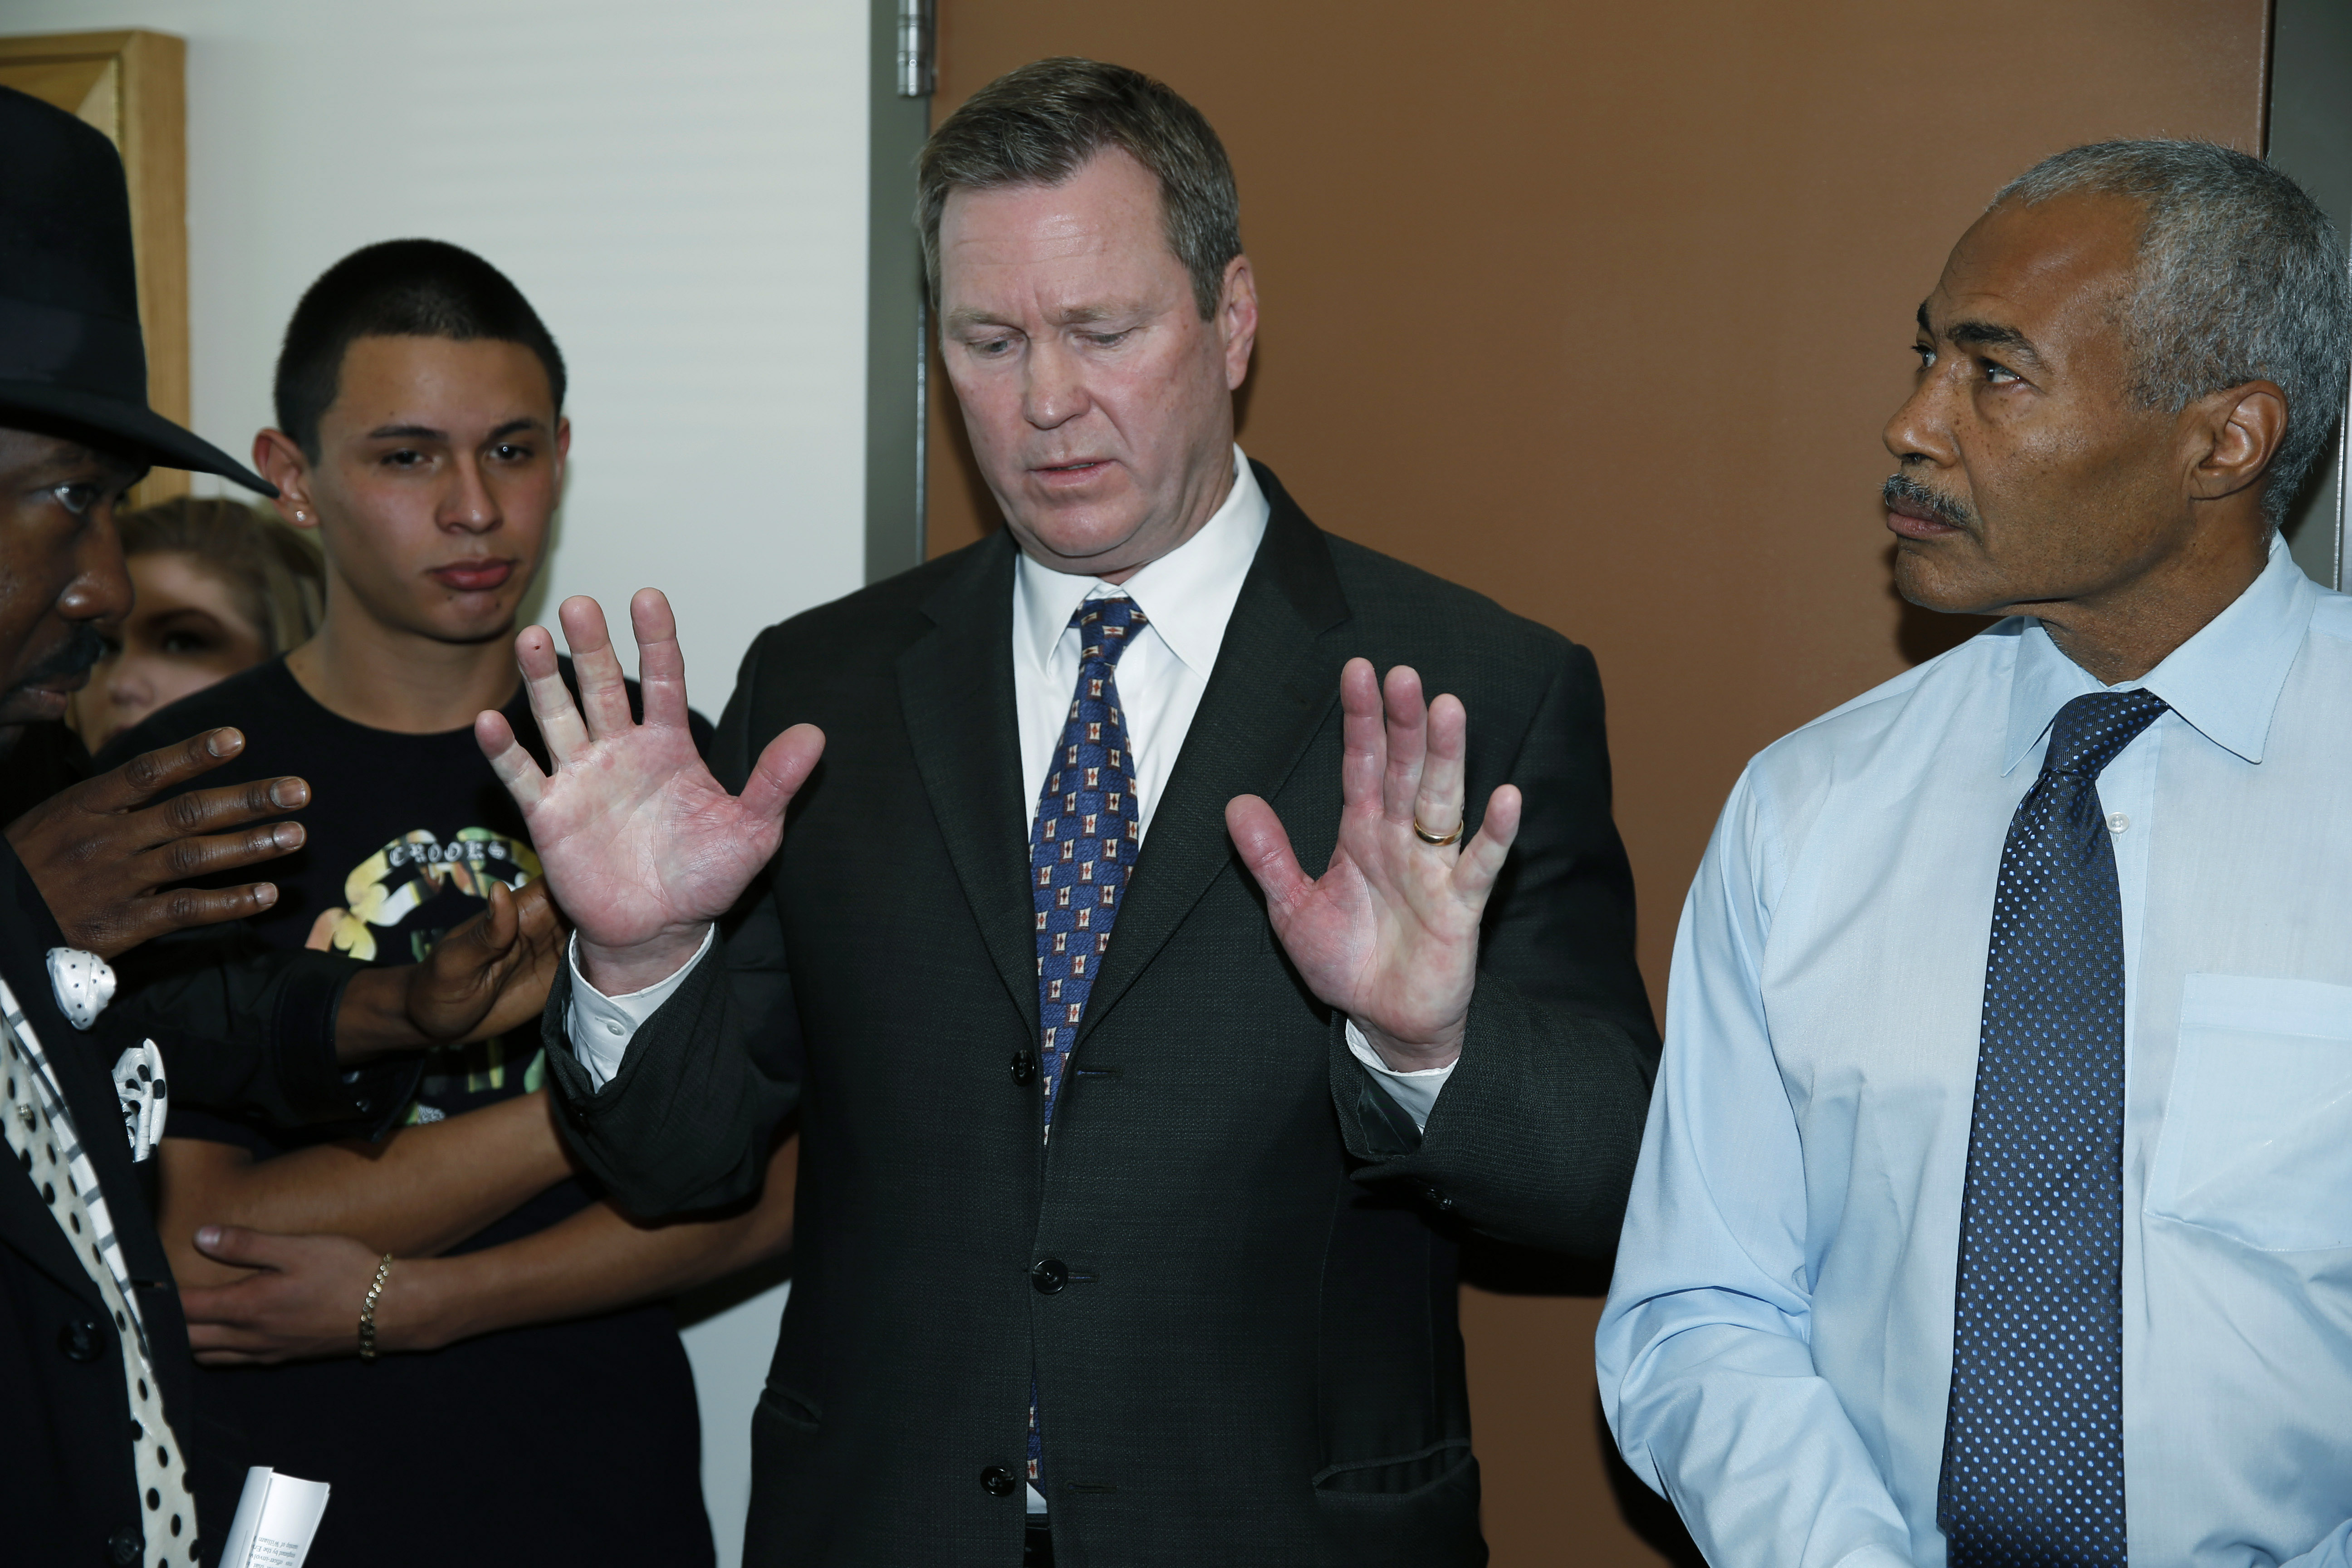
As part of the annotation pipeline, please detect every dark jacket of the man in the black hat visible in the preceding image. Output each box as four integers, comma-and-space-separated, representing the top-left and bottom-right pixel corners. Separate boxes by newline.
0, 842, 390, 1563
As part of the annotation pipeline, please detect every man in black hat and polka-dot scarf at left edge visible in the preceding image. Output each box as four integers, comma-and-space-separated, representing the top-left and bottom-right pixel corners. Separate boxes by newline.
0, 89, 550, 1568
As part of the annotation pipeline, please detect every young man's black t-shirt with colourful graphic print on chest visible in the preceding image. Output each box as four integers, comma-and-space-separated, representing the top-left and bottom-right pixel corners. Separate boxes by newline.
101, 661, 713, 1568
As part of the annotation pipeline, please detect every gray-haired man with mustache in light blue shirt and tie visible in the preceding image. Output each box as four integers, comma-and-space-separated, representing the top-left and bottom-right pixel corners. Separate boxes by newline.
1599, 141, 2352, 1568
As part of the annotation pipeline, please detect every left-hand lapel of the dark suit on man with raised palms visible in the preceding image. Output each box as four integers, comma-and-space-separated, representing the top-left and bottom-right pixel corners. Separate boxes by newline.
898, 531, 1037, 1018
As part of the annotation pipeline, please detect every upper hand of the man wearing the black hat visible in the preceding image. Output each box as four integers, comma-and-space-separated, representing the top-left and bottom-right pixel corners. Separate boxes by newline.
7, 729, 310, 959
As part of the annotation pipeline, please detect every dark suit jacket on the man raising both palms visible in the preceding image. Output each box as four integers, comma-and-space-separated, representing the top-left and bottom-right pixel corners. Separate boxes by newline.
548, 468, 1656, 1568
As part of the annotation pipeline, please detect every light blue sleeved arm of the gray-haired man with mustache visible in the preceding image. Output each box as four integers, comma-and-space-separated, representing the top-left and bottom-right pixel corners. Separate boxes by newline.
1599, 780, 1910, 1568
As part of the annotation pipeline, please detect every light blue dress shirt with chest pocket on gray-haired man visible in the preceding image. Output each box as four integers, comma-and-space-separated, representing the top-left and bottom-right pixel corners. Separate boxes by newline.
1599, 543, 2352, 1568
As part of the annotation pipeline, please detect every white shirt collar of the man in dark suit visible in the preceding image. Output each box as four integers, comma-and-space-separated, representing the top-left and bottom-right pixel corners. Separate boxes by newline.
1014, 446, 1268, 679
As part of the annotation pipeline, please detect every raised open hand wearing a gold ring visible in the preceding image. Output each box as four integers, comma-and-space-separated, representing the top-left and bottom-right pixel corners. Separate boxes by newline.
1225, 658, 1519, 1072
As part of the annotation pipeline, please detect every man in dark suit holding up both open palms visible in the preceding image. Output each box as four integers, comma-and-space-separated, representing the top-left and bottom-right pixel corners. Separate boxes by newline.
477, 61, 1656, 1568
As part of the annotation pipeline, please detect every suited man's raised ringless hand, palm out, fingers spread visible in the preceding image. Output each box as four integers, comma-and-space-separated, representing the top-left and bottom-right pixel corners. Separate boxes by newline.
473, 588, 826, 997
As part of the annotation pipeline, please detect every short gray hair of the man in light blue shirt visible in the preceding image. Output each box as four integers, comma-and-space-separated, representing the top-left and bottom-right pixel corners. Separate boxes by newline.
1992, 139, 2352, 527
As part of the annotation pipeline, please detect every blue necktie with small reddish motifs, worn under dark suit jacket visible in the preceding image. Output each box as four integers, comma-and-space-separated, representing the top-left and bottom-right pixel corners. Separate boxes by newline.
1028, 599, 1146, 1486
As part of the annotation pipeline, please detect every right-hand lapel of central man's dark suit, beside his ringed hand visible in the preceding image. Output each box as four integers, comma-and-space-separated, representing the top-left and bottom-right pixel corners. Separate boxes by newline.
1077, 480, 1348, 1039
